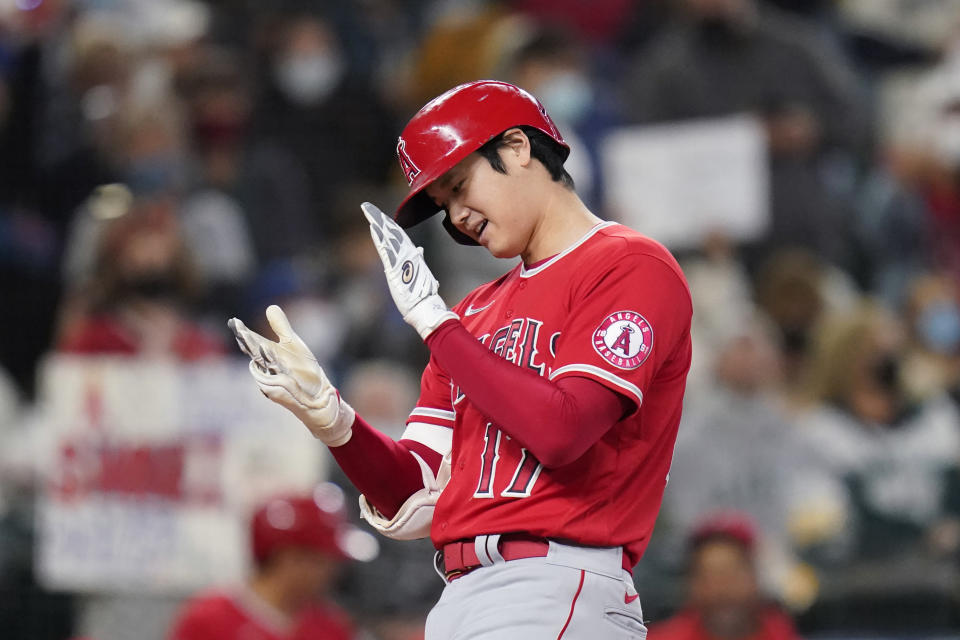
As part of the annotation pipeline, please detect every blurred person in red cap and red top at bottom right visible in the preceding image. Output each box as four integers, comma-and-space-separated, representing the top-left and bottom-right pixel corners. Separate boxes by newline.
648, 513, 799, 640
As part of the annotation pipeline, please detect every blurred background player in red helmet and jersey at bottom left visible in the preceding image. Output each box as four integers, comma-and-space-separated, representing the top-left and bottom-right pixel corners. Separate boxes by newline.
169, 484, 375, 640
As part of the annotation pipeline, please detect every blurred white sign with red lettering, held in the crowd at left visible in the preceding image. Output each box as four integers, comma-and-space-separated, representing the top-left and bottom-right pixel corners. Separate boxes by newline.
34, 356, 326, 592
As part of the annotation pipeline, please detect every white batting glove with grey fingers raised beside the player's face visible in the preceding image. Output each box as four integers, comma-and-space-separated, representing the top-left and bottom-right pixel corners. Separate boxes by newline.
360, 202, 460, 340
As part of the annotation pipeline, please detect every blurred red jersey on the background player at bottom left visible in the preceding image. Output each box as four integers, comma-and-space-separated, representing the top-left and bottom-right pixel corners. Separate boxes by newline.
169, 589, 355, 640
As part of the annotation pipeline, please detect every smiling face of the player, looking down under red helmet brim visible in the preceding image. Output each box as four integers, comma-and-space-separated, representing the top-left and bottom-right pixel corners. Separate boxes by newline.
426, 148, 532, 258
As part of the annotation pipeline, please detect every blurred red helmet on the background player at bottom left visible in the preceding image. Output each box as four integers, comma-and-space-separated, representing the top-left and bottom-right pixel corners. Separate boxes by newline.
250, 482, 377, 564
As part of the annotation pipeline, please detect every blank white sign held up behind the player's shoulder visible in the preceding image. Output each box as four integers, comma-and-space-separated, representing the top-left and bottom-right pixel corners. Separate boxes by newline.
601, 115, 770, 249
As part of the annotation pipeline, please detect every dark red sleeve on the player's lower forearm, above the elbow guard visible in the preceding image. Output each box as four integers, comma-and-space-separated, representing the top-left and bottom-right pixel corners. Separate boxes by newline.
330, 415, 441, 518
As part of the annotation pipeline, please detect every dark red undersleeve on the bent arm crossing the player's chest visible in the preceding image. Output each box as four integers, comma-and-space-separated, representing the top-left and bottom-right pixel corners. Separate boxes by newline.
427, 320, 634, 467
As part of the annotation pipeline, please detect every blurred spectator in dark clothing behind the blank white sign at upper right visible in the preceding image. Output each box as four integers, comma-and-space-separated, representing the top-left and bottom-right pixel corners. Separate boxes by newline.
622, 0, 868, 266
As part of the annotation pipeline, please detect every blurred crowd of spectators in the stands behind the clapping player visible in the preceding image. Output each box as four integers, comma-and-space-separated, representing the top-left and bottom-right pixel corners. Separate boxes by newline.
0, 0, 960, 640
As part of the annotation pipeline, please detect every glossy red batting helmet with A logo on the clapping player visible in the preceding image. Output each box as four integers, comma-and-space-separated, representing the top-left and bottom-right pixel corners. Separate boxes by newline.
394, 80, 570, 244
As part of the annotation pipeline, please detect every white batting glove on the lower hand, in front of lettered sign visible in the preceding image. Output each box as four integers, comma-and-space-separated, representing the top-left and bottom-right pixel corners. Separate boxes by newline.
227, 304, 356, 447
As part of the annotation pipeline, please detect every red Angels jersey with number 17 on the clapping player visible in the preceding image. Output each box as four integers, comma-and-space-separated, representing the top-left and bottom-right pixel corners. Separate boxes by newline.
408, 222, 693, 564
